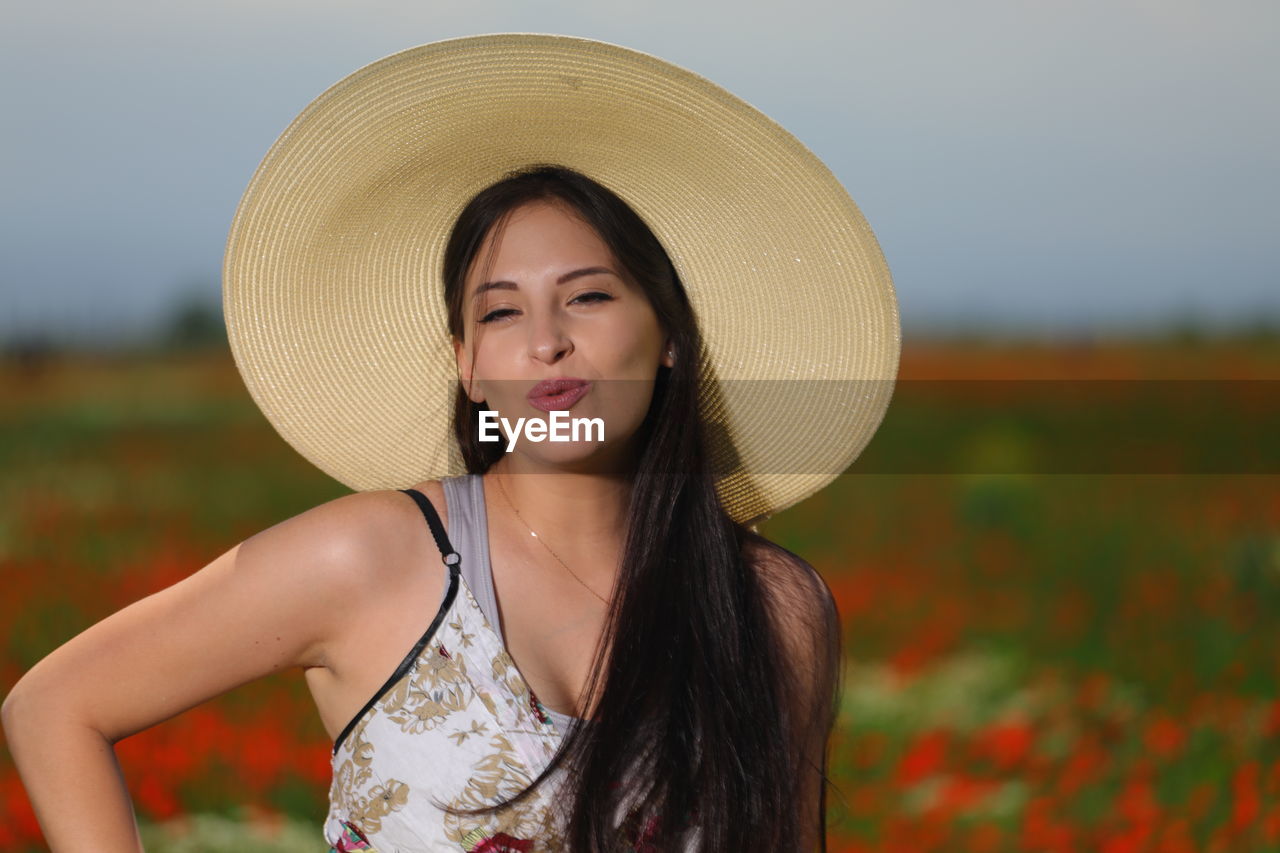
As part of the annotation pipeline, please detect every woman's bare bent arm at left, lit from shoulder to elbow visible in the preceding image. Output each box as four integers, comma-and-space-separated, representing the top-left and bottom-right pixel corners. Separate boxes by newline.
0, 493, 385, 853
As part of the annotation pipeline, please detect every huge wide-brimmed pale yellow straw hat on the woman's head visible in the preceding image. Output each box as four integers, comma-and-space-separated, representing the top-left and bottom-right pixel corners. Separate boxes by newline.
223, 33, 900, 521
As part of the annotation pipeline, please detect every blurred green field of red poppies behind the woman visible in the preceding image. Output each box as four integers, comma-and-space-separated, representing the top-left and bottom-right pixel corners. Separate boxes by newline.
0, 339, 1280, 853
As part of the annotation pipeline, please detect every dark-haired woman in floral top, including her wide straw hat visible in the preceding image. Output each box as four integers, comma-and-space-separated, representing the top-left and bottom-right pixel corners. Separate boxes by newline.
5, 36, 897, 853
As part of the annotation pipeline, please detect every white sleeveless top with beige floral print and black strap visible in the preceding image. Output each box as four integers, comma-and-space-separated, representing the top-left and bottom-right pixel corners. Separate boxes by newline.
324, 474, 691, 853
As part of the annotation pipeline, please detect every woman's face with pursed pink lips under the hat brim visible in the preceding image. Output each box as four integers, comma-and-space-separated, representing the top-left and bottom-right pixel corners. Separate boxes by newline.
454, 201, 672, 465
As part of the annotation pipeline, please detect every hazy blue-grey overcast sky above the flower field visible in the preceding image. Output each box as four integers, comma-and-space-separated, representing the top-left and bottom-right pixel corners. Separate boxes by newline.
0, 0, 1280, 343
